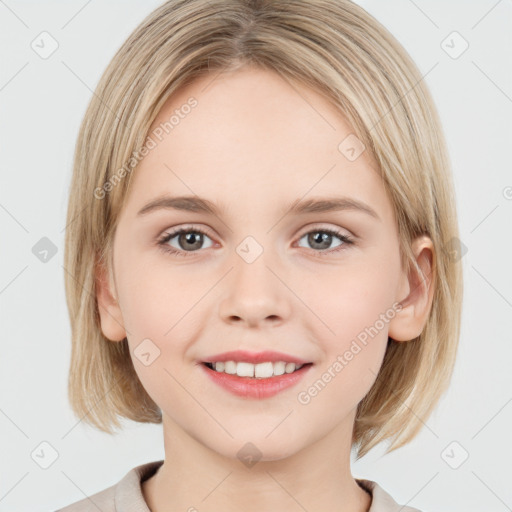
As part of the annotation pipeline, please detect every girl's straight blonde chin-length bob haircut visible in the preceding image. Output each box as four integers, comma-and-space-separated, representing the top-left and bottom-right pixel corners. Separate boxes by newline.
64, 0, 463, 459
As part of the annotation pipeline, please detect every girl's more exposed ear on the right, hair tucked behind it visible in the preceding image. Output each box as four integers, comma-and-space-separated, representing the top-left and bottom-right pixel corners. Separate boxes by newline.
388, 235, 435, 342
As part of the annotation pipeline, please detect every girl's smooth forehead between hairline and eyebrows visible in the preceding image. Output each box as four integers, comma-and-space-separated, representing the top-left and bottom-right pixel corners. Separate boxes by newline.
122, 68, 390, 220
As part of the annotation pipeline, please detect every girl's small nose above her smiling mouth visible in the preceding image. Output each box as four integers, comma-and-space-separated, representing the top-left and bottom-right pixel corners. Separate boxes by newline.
219, 253, 291, 328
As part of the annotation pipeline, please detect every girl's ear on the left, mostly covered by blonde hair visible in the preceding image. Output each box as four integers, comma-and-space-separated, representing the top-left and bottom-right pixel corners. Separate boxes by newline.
95, 255, 126, 341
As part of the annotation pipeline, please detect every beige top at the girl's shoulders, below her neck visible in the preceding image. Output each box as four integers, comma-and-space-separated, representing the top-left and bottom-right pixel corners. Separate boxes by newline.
56, 460, 421, 512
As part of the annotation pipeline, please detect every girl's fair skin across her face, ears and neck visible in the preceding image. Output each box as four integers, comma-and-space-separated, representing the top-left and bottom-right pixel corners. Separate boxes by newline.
98, 68, 433, 512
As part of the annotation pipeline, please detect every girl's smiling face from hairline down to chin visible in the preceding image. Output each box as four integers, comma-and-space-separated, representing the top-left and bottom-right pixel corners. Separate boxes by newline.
98, 68, 426, 460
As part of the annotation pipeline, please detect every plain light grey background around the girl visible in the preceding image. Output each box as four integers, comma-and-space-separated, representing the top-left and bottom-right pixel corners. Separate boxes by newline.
0, 0, 512, 512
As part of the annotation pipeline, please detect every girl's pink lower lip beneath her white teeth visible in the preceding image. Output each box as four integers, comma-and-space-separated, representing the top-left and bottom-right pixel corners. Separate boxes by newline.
201, 364, 312, 398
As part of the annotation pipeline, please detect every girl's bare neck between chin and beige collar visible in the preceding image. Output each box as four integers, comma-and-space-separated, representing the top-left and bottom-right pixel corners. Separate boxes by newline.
142, 415, 372, 512
